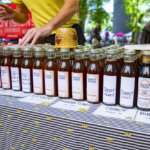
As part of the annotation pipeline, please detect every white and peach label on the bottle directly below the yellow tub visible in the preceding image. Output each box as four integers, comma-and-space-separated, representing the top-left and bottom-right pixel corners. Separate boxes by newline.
58, 71, 69, 97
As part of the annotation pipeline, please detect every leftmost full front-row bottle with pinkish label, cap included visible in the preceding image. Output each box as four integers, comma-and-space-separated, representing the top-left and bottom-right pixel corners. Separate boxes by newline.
1, 46, 12, 89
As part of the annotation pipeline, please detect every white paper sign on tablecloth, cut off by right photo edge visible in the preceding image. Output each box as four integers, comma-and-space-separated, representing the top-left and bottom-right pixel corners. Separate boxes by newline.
135, 110, 150, 124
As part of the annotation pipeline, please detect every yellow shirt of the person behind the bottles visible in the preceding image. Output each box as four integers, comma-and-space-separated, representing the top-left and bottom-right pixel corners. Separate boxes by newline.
11, 0, 80, 32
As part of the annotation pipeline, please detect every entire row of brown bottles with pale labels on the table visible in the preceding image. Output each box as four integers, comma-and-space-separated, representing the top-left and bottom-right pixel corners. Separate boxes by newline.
0, 47, 150, 110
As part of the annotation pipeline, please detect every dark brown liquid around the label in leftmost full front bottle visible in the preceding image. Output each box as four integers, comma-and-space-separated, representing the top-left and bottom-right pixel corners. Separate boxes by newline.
2, 56, 12, 89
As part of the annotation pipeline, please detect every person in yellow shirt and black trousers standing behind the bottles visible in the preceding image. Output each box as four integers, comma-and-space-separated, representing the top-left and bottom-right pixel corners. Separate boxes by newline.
0, 0, 85, 46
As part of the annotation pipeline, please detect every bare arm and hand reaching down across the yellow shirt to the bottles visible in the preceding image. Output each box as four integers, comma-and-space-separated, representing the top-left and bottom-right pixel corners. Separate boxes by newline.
19, 0, 79, 45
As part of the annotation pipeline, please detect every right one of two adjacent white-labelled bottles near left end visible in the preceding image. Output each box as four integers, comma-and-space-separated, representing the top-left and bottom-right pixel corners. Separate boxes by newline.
21, 47, 33, 93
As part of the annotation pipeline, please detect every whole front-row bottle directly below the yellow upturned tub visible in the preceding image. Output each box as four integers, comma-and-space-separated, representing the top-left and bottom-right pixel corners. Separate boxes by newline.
58, 49, 71, 98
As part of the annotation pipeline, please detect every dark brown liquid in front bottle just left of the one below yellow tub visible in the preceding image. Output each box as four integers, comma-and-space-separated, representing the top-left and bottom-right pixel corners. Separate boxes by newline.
45, 58, 58, 96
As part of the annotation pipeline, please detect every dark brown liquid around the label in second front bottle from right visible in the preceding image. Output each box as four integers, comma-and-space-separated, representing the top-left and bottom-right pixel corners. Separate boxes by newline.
120, 62, 137, 108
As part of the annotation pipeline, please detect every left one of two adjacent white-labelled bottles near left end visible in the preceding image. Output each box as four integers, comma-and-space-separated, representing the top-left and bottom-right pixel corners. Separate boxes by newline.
11, 46, 22, 91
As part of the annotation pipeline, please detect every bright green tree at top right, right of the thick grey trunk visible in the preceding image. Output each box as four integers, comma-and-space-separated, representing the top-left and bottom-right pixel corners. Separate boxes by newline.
124, 0, 149, 43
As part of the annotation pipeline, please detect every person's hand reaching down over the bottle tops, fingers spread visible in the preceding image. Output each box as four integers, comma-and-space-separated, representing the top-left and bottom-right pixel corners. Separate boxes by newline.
18, 26, 52, 46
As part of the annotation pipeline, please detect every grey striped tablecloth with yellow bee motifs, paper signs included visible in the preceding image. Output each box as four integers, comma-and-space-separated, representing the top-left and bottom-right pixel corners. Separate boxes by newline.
0, 91, 150, 150
